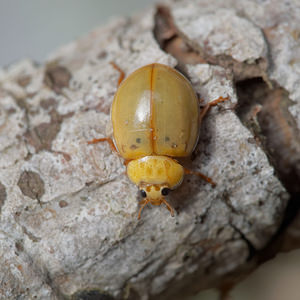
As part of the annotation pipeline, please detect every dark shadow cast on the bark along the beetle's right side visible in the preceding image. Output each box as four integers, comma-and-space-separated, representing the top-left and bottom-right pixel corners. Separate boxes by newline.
168, 112, 221, 213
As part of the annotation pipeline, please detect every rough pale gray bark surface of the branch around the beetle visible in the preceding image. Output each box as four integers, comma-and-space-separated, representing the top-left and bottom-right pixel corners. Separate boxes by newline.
0, 0, 300, 299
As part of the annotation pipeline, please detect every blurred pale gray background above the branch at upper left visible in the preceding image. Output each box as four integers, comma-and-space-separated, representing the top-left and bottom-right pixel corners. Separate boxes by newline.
0, 0, 157, 66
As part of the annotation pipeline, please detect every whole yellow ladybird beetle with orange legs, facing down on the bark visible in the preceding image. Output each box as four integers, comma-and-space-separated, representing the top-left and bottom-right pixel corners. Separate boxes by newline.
88, 63, 228, 219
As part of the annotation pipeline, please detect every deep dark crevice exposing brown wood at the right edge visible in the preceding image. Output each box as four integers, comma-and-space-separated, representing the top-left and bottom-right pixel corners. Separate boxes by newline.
236, 78, 300, 195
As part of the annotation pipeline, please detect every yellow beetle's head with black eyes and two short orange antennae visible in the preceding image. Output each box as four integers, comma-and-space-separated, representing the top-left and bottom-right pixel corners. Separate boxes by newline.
138, 184, 174, 219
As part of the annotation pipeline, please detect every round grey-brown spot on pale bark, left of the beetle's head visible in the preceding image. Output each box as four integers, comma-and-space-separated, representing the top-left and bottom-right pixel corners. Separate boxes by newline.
18, 171, 45, 201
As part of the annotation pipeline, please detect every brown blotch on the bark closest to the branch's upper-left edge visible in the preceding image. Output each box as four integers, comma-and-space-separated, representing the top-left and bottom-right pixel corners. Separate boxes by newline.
44, 64, 72, 94
